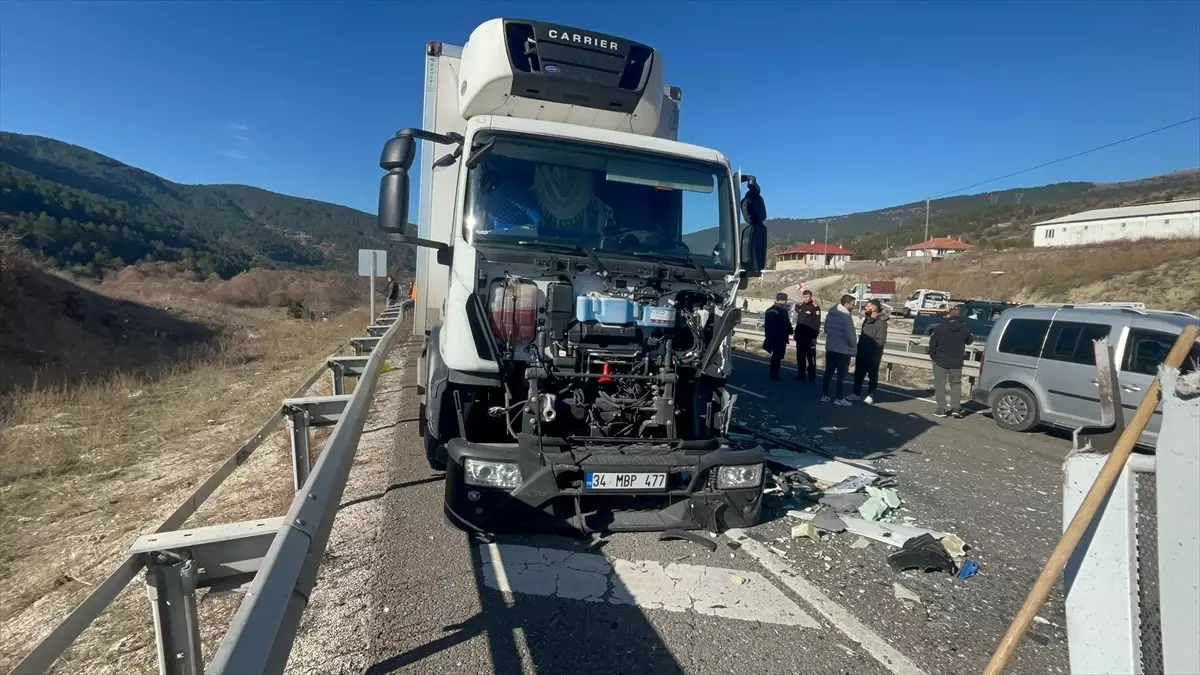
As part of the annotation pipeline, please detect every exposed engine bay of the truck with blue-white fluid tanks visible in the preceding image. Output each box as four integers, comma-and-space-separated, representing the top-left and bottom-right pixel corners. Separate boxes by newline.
456, 254, 740, 447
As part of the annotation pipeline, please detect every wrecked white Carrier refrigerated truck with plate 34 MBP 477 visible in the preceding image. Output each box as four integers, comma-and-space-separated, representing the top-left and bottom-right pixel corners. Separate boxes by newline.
379, 19, 766, 532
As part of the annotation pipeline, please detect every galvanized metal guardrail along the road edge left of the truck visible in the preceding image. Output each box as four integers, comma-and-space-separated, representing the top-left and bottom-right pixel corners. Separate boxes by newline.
11, 300, 413, 675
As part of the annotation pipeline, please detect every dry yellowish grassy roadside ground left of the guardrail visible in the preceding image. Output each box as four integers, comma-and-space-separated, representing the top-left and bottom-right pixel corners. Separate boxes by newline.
0, 270, 367, 673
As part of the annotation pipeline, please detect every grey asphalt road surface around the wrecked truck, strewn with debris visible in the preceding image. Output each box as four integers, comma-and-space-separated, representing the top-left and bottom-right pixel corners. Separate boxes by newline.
288, 344, 1069, 675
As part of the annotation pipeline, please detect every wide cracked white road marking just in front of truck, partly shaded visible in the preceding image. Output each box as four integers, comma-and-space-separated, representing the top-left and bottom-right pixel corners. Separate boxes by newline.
480, 544, 818, 628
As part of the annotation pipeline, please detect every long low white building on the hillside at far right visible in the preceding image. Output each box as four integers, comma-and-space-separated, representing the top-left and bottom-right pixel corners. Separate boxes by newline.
1033, 199, 1200, 246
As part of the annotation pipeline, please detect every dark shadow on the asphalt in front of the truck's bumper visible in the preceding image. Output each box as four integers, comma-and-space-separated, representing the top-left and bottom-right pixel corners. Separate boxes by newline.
366, 537, 683, 675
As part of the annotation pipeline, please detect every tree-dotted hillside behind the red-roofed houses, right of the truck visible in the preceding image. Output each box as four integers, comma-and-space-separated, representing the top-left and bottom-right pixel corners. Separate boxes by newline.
685, 169, 1200, 259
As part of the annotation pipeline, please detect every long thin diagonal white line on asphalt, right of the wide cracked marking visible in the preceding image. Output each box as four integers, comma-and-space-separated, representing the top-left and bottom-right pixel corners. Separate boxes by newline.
725, 528, 926, 675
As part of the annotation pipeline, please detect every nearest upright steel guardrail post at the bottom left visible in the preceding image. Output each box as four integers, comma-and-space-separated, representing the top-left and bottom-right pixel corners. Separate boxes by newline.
146, 554, 204, 675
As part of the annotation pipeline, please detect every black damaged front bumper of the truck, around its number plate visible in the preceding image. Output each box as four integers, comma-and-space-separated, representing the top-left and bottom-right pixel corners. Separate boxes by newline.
445, 438, 764, 533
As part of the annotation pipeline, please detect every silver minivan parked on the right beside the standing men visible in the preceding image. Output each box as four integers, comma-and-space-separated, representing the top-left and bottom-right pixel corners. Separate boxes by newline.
972, 305, 1200, 447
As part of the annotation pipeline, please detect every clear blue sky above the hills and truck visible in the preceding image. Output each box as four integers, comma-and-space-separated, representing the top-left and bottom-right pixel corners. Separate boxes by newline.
0, 0, 1200, 217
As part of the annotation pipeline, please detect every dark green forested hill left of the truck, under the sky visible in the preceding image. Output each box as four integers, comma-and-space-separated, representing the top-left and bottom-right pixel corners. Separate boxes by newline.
0, 132, 413, 276
